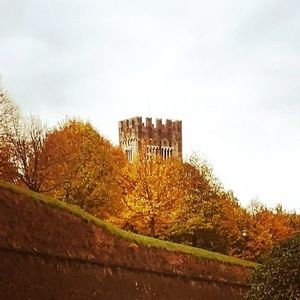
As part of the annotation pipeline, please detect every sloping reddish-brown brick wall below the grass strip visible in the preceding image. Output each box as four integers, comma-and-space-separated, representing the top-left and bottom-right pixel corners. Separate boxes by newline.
0, 186, 253, 300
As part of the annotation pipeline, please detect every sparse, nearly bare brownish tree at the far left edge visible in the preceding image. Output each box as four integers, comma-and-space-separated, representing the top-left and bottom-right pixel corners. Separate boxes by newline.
0, 86, 49, 192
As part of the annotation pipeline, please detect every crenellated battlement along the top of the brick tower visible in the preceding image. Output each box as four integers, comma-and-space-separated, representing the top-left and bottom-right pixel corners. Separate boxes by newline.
119, 117, 182, 131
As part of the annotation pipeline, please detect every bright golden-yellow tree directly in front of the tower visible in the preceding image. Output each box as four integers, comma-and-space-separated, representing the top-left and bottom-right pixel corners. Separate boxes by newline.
116, 154, 186, 238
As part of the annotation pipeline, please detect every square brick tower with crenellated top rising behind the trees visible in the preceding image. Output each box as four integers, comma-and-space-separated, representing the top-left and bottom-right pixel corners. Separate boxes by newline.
119, 117, 182, 161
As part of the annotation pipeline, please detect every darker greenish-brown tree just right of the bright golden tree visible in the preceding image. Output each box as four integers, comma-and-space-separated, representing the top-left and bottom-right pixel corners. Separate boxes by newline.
170, 154, 245, 255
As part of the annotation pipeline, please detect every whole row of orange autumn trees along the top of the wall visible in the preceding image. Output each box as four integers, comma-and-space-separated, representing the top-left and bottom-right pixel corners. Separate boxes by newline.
0, 90, 300, 261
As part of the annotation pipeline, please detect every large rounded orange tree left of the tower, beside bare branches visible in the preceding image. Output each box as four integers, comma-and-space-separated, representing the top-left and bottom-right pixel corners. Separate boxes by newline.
42, 119, 125, 218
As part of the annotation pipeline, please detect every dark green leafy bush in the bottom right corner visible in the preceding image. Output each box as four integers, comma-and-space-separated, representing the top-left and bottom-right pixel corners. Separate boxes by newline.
247, 234, 300, 300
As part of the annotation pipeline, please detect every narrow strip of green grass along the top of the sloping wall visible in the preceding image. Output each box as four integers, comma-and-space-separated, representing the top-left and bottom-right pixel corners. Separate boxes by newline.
0, 180, 258, 268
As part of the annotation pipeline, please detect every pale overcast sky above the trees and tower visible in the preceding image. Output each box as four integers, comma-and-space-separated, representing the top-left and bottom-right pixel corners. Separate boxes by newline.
0, 0, 300, 212
